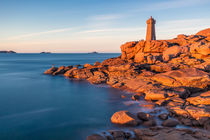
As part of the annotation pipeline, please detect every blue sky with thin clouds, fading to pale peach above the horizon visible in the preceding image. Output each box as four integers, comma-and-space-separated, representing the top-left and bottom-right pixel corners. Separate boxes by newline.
0, 0, 210, 53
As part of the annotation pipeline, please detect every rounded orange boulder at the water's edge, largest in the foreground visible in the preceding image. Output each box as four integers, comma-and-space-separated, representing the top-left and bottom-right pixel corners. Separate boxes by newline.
111, 111, 140, 126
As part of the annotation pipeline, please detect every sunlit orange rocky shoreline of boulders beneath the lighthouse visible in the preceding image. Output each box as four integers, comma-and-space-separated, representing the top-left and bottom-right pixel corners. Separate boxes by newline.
44, 25, 210, 140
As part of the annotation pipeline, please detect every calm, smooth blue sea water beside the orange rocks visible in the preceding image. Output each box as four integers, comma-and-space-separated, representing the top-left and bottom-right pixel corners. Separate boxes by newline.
0, 54, 135, 140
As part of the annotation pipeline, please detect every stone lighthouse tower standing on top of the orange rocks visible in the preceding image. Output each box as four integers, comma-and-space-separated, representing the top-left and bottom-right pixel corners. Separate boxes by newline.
146, 16, 156, 41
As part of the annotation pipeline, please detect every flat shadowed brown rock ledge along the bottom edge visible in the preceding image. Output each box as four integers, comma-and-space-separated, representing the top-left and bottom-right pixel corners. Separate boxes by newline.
87, 127, 210, 140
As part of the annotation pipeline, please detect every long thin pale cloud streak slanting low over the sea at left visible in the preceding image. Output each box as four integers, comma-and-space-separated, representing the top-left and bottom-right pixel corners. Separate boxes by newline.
7, 28, 73, 40
